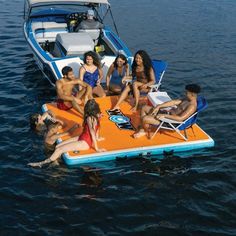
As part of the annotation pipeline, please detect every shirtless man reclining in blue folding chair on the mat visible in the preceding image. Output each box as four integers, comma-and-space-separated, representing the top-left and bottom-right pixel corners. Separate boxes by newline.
133, 84, 201, 138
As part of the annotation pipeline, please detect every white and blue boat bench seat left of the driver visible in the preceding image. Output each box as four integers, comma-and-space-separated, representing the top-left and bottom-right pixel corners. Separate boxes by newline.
32, 22, 68, 43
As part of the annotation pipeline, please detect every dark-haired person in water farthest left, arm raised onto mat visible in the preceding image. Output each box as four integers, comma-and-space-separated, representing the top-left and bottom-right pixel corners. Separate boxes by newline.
30, 111, 64, 132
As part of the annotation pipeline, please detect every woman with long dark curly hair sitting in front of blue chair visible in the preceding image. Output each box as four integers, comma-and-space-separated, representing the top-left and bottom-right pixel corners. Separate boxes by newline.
112, 50, 155, 112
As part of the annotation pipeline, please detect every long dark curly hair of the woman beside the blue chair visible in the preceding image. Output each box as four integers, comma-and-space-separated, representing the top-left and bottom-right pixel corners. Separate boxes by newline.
132, 50, 153, 78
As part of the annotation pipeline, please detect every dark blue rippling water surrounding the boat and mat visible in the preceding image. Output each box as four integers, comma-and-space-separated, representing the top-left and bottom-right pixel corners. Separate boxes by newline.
0, 0, 236, 235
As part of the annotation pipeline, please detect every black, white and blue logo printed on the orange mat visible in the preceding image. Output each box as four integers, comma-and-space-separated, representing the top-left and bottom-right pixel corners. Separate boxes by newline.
106, 110, 135, 130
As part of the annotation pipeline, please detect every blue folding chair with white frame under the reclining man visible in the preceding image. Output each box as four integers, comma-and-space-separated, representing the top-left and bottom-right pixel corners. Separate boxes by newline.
151, 96, 208, 141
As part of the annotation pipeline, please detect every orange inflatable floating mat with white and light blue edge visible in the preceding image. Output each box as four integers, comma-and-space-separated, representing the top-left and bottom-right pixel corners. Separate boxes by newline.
42, 96, 214, 166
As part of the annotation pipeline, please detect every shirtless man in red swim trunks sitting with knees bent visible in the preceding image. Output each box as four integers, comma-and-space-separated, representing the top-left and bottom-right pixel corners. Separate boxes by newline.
56, 66, 92, 115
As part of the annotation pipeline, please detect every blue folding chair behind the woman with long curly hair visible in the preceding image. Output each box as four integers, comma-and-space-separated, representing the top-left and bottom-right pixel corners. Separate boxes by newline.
149, 60, 167, 92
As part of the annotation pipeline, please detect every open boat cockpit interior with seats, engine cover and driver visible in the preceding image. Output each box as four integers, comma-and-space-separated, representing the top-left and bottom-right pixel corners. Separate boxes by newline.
28, 4, 121, 58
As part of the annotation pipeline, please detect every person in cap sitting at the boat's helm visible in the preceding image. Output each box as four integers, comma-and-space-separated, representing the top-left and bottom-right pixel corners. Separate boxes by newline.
75, 9, 103, 31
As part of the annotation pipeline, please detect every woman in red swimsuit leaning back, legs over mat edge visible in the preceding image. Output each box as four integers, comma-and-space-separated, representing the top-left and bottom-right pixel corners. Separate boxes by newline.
28, 99, 106, 167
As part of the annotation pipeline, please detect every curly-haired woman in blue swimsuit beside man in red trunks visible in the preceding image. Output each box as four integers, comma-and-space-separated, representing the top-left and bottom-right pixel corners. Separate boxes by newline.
79, 51, 106, 98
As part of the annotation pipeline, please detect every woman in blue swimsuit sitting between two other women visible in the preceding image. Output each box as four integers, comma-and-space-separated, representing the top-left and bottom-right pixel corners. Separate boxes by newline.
106, 54, 129, 94
